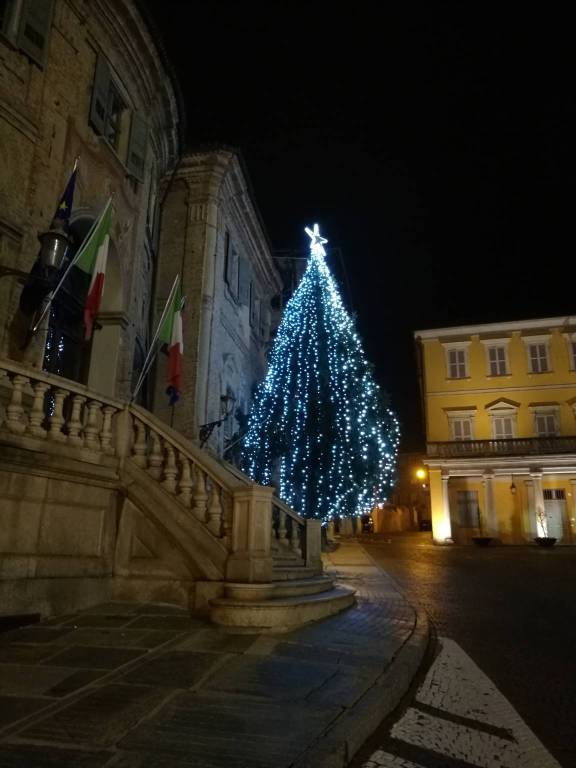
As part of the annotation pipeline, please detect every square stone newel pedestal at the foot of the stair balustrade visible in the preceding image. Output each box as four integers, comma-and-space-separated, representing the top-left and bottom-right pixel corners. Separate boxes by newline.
226, 483, 274, 584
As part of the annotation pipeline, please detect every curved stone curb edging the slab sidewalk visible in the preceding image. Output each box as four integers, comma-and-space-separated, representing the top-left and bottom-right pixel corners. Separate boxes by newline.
291, 544, 431, 768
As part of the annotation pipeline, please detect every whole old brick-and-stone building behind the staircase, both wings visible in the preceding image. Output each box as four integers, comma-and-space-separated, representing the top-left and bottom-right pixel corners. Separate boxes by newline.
0, 0, 283, 453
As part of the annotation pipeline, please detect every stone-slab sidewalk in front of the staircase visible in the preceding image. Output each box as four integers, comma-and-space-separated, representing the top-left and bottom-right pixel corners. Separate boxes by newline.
0, 540, 428, 768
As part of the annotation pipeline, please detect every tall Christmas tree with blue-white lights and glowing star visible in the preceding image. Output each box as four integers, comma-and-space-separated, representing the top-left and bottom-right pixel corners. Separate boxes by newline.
243, 224, 399, 521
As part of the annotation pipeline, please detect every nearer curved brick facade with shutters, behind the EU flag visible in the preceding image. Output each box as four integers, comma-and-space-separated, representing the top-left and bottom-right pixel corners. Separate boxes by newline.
0, 0, 181, 398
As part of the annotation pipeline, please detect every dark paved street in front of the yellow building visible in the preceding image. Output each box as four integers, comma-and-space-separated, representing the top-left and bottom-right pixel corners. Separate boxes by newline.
356, 534, 576, 768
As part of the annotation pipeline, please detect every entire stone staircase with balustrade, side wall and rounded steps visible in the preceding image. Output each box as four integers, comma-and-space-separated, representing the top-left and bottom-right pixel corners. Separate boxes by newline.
0, 360, 354, 632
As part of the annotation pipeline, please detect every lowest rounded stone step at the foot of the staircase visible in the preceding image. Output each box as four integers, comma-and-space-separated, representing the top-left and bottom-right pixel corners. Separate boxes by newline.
210, 587, 355, 634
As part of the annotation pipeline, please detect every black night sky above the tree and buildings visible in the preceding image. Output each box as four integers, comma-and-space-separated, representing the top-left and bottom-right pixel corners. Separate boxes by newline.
146, 0, 576, 450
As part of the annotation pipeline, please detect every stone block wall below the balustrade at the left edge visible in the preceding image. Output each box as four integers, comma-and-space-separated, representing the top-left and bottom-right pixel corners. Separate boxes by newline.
0, 440, 118, 615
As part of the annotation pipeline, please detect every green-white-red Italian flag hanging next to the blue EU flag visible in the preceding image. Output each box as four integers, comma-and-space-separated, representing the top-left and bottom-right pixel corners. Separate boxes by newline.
74, 198, 112, 339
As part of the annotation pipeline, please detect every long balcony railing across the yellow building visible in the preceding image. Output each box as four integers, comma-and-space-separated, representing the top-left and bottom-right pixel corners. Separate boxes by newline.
427, 436, 576, 459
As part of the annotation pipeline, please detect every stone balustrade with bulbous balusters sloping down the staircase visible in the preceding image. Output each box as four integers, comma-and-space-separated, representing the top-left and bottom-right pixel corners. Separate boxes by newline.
0, 360, 320, 582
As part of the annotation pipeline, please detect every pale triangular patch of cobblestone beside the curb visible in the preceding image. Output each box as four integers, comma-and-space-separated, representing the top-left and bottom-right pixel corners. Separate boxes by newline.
362, 638, 560, 768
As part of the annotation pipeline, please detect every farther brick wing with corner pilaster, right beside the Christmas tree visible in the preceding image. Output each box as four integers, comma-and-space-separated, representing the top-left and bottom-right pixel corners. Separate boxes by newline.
154, 148, 283, 450
